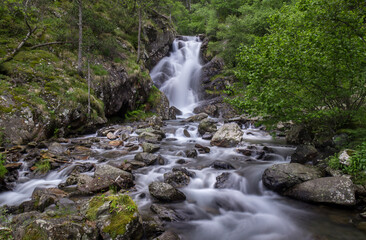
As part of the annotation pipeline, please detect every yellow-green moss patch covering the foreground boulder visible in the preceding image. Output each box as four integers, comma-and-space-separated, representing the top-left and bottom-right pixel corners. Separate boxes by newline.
86, 195, 137, 239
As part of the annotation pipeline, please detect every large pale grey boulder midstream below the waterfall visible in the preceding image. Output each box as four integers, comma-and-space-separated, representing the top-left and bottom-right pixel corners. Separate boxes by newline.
211, 123, 243, 147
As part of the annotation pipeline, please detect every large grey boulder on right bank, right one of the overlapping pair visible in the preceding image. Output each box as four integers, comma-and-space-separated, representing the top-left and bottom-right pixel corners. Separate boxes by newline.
285, 177, 356, 206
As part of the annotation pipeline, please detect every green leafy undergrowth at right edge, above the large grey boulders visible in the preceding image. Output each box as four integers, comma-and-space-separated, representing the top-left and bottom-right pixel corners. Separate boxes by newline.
327, 142, 366, 185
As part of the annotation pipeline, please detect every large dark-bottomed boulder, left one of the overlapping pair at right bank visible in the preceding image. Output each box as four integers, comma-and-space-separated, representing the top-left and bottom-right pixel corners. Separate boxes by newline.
262, 163, 323, 193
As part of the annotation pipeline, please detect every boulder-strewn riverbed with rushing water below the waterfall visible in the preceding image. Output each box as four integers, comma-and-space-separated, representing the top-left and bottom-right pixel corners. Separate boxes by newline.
0, 113, 366, 239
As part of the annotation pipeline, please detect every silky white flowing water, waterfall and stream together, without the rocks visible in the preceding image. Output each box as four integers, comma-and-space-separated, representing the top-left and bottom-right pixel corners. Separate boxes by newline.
0, 37, 366, 240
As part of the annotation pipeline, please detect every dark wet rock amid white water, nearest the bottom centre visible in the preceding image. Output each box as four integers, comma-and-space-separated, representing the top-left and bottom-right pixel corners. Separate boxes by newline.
149, 182, 186, 202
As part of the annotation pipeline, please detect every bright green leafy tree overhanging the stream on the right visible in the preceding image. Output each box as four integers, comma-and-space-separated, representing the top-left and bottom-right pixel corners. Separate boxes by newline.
232, 0, 366, 129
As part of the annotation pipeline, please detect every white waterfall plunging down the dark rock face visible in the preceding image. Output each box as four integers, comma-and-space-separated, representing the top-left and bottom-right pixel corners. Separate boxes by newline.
150, 36, 202, 114
